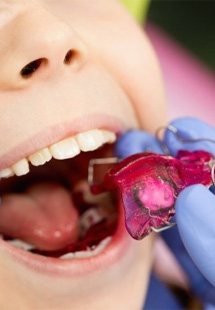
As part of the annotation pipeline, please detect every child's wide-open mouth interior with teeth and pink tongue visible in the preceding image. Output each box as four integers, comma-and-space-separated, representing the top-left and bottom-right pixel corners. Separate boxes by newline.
0, 129, 126, 266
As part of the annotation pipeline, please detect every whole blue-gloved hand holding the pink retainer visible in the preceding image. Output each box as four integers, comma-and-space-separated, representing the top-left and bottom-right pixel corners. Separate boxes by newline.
116, 118, 215, 304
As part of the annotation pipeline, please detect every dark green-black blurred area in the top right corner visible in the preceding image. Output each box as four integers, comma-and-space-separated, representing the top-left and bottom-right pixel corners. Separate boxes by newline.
148, 0, 215, 70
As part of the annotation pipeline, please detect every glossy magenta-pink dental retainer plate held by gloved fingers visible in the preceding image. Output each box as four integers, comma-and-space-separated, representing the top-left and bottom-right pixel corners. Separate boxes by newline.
92, 151, 213, 240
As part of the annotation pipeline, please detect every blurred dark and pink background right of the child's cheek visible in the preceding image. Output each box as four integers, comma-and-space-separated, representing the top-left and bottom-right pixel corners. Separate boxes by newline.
140, 0, 215, 126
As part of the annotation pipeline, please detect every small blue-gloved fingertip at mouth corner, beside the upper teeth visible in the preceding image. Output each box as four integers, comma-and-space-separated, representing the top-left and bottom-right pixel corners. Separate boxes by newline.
115, 130, 162, 158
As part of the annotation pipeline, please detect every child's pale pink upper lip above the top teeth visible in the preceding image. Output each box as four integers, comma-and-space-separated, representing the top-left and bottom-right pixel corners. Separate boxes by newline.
0, 115, 125, 170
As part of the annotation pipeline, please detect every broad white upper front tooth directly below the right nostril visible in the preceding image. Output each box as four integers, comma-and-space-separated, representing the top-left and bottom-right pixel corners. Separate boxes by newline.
49, 138, 80, 159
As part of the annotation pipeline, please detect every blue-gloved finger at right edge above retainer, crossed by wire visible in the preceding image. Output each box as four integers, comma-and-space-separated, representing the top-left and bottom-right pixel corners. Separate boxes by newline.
164, 117, 215, 156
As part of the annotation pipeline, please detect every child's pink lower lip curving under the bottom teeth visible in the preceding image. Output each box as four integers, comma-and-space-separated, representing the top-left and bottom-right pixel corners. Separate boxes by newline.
0, 202, 133, 277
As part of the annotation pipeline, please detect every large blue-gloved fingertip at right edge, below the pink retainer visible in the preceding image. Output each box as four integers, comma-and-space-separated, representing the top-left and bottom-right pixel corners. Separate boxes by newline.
176, 185, 215, 286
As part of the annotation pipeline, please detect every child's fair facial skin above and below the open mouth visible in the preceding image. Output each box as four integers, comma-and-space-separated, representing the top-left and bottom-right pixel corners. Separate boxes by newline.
0, 0, 166, 309
